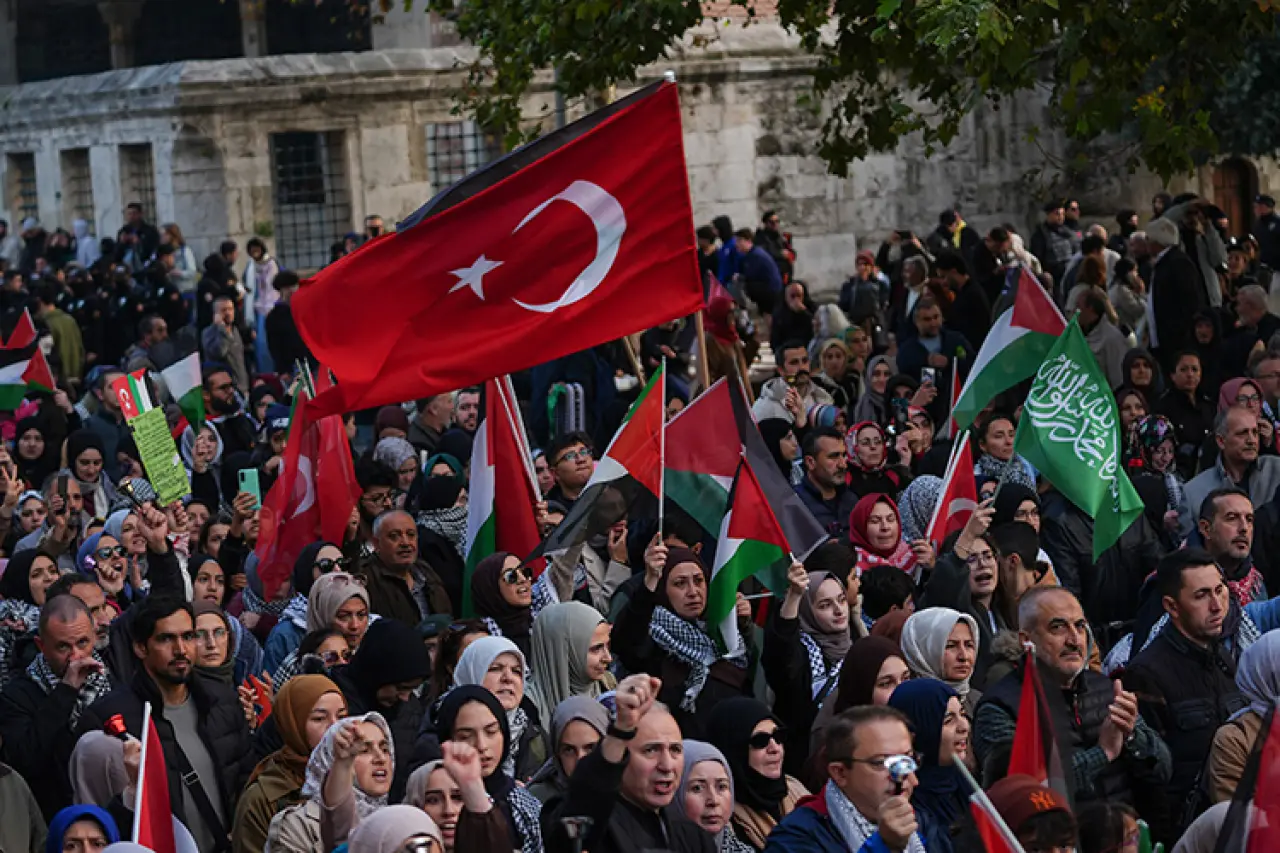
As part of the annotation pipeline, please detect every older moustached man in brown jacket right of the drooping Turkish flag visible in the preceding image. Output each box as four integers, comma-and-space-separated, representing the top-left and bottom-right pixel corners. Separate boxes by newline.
360, 510, 449, 625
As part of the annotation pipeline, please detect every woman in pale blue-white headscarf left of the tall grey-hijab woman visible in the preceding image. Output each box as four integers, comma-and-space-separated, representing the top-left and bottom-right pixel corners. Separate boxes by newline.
453, 637, 550, 781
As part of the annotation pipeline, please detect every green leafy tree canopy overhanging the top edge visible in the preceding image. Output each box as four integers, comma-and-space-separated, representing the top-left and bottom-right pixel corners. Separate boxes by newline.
380, 0, 1280, 177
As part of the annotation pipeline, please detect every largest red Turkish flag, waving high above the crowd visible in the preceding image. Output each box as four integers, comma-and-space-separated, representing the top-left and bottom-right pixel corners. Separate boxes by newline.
292, 83, 703, 414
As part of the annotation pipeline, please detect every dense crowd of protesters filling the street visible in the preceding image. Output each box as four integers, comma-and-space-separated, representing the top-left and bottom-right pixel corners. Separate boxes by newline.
0, 193, 1280, 853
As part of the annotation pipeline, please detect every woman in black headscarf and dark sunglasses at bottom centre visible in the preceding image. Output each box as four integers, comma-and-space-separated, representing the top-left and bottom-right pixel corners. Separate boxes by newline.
707, 697, 809, 850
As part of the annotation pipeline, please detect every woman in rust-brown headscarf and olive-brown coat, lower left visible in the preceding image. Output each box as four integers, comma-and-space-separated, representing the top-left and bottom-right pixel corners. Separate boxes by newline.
232, 675, 347, 853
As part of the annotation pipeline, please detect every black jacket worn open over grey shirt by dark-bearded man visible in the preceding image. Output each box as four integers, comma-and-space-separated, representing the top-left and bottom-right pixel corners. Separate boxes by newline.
77, 669, 253, 829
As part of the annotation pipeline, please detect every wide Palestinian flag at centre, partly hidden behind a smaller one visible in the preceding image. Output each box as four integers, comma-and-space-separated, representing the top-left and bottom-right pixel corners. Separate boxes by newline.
667, 377, 827, 597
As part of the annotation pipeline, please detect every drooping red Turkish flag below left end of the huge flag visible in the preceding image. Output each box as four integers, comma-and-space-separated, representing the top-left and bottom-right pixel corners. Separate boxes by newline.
255, 381, 360, 601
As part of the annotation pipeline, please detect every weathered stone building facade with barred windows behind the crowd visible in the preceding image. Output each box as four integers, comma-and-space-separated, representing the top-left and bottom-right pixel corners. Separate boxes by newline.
0, 0, 1280, 291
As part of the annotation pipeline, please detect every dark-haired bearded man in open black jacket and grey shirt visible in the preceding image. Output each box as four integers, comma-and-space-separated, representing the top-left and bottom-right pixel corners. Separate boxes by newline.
78, 596, 253, 853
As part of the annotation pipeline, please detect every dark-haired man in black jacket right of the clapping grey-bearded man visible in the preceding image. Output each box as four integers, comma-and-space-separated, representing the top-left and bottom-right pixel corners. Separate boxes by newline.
1124, 548, 1252, 844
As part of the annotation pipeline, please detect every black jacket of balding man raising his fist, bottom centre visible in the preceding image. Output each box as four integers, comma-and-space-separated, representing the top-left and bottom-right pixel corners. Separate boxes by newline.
541, 749, 716, 853
